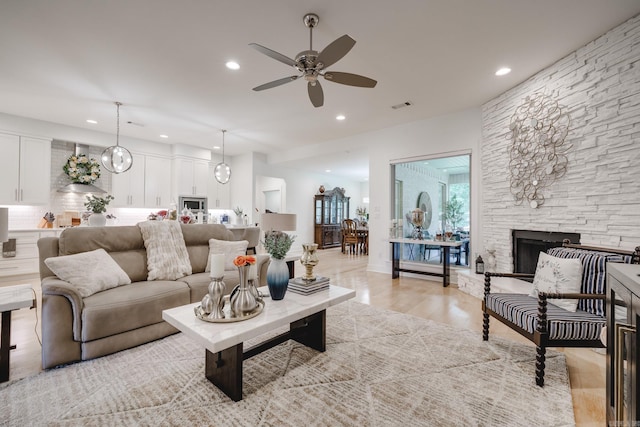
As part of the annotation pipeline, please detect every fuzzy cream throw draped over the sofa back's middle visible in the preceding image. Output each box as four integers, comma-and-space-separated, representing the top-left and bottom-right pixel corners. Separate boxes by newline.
138, 221, 192, 280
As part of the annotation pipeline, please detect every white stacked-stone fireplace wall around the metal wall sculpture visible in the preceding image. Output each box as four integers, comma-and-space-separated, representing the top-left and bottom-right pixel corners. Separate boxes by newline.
482, 16, 640, 271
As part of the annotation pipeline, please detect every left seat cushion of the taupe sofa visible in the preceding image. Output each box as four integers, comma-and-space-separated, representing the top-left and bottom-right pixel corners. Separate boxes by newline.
81, 280, 191, 341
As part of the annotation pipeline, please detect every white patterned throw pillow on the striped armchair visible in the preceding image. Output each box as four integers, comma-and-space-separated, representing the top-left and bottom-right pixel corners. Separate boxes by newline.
529, 252, 582, 311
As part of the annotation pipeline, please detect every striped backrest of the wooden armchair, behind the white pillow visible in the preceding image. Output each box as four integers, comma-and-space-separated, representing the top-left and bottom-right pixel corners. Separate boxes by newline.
547, 247, 632, 316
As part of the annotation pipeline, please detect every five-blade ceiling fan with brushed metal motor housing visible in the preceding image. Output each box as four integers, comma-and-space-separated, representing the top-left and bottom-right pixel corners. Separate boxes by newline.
249, 13, 378, 107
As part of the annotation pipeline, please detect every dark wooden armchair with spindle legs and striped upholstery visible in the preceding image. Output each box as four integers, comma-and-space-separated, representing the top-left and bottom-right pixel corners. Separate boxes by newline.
482, 241, 640, 387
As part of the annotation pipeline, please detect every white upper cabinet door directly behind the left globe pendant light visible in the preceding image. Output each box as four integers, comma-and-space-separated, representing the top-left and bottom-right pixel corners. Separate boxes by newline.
111, 154, 145, 208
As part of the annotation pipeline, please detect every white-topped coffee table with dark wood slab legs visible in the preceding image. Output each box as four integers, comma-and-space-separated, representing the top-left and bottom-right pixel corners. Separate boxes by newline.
162, 286, 356, 402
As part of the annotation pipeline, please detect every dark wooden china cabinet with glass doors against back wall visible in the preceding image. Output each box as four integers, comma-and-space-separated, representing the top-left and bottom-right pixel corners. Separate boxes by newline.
314, 187, 349, 249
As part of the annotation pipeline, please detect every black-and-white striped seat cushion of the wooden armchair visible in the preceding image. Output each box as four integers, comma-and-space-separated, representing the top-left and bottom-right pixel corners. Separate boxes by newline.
486, 294, 606, 340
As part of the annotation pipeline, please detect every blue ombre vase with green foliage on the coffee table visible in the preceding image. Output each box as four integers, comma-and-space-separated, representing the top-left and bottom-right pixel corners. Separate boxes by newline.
262, 231, 295, 300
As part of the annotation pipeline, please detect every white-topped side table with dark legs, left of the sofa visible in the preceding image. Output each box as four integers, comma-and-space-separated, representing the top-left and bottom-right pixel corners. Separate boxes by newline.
0, 285, 36, 383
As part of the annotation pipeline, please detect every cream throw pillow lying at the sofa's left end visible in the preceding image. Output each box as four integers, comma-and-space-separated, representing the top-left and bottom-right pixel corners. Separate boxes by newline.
44, 249, 131, 298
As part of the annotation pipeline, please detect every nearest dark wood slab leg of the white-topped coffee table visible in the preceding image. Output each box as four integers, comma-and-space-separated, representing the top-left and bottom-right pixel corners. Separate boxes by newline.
205, 343, 243, 402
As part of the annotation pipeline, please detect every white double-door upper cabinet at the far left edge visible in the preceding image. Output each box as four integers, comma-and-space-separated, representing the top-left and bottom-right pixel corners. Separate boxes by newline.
0, 133, 51, 205
